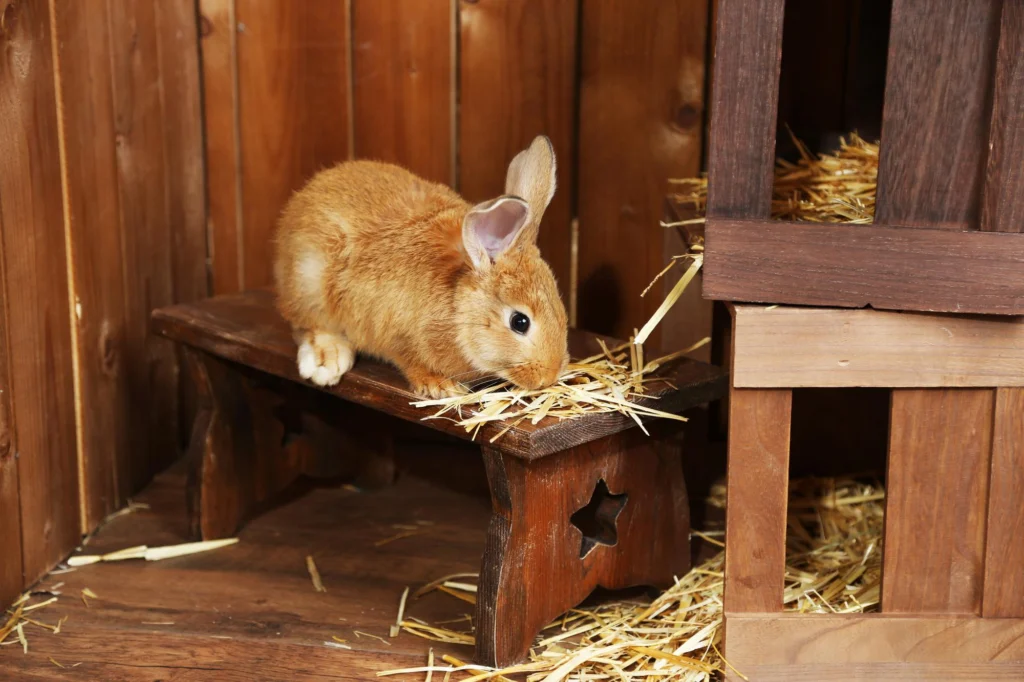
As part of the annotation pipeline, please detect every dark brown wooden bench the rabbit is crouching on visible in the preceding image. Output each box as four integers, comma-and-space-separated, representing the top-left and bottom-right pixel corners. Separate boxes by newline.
153, 291, 727, 666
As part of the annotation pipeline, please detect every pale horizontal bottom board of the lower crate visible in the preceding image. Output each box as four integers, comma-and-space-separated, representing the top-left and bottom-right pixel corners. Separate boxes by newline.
725, 613, 1024, 682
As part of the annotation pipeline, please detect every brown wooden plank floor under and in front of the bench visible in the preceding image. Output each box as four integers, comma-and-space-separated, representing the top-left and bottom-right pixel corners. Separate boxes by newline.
0, 417, 724, 682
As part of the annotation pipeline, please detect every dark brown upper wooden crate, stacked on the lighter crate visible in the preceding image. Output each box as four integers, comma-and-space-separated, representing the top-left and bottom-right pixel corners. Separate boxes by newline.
703, 0, 1024, 314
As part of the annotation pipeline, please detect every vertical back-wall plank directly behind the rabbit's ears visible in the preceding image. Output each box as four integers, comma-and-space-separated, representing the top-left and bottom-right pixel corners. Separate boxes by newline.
459, 0, 578, 302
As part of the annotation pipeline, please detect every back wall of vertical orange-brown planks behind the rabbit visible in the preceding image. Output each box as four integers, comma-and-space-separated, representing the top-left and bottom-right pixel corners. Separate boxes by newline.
199, 0, 710, 349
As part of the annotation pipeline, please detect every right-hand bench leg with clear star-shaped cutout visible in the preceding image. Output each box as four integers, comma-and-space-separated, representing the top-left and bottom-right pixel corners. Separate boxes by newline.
476, 429, 689, 666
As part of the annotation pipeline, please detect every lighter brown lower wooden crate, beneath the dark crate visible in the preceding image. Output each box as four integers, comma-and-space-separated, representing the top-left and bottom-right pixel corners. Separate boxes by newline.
725, 305, 1024, 682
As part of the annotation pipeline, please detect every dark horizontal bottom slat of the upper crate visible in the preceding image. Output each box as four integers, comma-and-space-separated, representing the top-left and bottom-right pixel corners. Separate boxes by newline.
703, 219, 1024, 314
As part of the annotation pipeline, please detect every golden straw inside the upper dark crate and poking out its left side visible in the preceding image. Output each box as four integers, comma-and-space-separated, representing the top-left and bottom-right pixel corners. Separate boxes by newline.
663, 132, 879, 227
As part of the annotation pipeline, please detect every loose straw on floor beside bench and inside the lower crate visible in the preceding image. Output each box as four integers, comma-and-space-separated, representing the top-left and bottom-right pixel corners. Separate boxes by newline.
378, 479, 885, 682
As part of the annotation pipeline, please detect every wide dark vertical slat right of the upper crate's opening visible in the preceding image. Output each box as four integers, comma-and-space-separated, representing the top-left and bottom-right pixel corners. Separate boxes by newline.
874, 0, 1002, 230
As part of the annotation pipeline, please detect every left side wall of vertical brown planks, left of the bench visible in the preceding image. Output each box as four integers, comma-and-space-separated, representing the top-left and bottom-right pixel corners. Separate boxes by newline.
0, 0, 208, 603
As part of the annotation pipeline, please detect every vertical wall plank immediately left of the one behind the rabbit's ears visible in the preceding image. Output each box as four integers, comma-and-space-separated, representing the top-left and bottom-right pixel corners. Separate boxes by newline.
352, 0, 450, 184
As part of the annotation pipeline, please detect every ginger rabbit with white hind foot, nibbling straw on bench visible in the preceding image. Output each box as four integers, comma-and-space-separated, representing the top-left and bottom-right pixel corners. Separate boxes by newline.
274, 135, 568, 398
